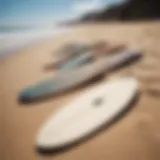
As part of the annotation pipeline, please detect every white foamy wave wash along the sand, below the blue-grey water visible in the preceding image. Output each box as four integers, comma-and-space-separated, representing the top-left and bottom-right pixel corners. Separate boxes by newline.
0, 27, 71, 62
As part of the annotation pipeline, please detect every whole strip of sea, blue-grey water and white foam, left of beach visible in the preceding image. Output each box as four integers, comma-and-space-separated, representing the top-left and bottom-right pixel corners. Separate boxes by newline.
0, 25, 69, 60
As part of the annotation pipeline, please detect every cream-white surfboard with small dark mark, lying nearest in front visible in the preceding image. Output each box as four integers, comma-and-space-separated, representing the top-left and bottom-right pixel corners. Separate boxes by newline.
36, 77, 138, 153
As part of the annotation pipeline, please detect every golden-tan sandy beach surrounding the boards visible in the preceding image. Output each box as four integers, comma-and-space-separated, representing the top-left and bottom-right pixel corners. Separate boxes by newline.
0, 22, 160, 160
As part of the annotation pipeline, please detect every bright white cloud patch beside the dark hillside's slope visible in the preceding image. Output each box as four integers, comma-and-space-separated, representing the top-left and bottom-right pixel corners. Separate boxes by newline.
72, 0, 104, 15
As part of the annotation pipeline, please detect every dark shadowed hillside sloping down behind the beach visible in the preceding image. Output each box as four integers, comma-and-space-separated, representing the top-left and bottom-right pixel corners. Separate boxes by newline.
81, 0, 160, 21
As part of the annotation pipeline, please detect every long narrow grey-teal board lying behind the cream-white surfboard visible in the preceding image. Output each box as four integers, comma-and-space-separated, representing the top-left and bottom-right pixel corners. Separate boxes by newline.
19, 50, 140, 102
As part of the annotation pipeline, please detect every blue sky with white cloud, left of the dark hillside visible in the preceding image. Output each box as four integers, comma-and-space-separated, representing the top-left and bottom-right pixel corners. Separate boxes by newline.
0, 0, 124, 25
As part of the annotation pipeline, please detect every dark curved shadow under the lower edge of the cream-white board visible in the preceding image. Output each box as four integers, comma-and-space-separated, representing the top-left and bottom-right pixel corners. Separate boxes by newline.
35, 92, 141, 156
